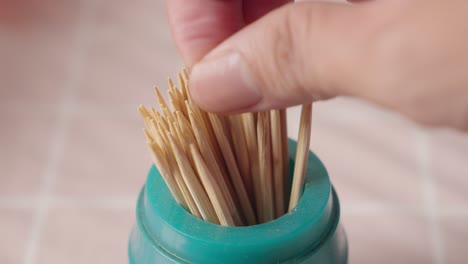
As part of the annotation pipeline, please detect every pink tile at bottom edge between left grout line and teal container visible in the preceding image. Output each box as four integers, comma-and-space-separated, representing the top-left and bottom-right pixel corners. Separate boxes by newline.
37, 208, 135, 264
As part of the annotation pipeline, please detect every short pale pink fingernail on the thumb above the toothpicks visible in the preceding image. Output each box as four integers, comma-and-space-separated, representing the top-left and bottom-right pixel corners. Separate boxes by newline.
190, 51, 262, 112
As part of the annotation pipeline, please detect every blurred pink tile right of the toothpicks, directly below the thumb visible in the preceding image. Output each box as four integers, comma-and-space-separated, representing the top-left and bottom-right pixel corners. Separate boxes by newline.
290, 99, 423, 207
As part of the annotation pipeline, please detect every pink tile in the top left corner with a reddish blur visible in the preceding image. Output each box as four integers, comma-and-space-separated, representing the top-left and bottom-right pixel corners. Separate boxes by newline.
0, 0, 80, 103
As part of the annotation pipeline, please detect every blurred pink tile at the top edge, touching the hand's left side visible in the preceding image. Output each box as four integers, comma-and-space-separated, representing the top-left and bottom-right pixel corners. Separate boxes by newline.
78, 0, 183, 105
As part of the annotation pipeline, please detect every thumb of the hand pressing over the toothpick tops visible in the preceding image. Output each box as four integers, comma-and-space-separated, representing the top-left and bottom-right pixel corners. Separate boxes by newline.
190, 2, 374, 112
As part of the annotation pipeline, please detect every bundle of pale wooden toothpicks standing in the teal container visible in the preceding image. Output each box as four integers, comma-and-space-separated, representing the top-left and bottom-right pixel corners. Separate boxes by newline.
139, 70, 312, 226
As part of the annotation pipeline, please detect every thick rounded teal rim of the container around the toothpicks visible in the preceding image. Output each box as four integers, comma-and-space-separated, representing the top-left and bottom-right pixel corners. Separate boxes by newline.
138, 140, 339, 263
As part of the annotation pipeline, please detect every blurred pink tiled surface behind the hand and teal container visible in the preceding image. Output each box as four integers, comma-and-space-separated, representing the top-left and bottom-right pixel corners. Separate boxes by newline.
0, 0, 468, 264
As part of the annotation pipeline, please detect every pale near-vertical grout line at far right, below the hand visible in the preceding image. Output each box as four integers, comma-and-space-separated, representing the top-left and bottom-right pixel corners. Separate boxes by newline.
416, 128, 446, 264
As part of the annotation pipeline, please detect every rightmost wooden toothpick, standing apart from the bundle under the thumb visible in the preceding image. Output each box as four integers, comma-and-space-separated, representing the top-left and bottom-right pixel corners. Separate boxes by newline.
288, 104, 312, 211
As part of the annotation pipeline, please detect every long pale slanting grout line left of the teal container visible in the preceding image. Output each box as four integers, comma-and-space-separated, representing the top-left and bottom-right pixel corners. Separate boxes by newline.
23, 1, 96, 264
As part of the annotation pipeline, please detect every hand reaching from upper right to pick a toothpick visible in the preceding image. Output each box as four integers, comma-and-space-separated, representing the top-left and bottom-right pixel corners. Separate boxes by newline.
167, 0, 468, 131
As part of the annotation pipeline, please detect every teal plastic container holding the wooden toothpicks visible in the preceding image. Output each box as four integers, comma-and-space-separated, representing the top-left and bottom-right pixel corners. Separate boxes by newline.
128, 141, 348, 264
